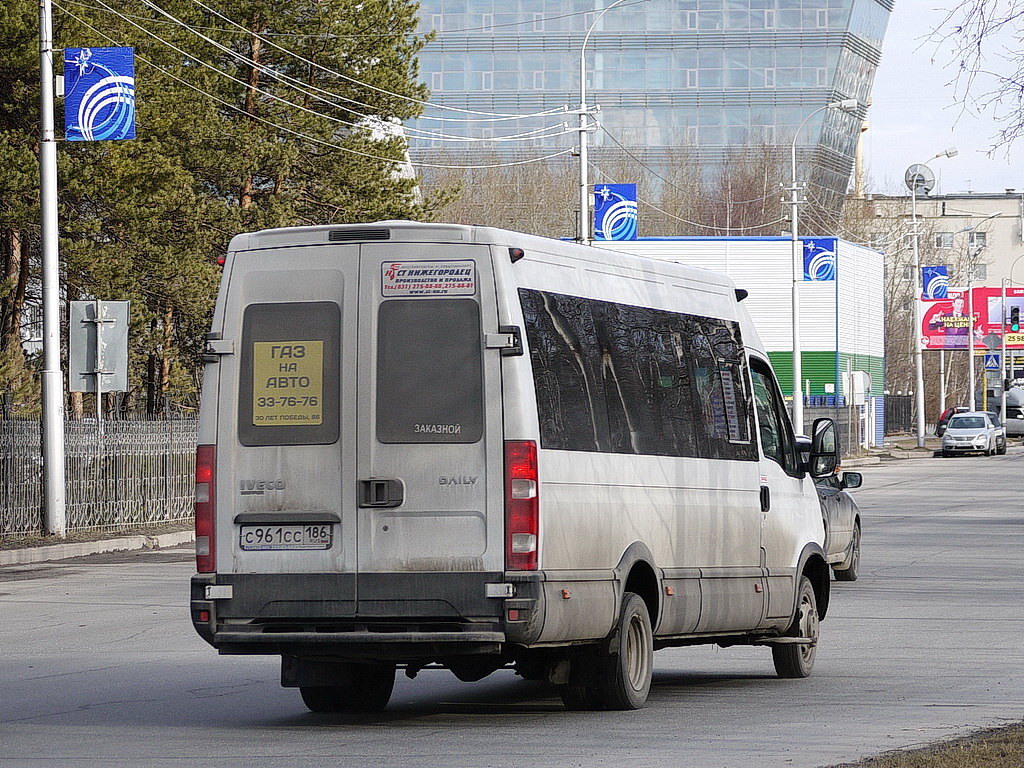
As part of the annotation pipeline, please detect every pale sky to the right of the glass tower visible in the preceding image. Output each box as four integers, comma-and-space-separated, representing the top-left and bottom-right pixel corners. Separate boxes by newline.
864, 0, 1024, 193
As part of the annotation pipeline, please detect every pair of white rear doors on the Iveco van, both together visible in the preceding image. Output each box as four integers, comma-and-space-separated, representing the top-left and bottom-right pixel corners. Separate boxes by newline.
216, 243, 504, 621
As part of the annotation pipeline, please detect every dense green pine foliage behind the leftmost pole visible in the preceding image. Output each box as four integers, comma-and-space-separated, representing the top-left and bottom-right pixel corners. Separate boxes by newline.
0, 0, 442, 411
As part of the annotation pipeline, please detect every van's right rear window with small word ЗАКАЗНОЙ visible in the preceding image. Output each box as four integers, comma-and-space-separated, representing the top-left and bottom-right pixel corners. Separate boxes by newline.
377, 299, 483, 442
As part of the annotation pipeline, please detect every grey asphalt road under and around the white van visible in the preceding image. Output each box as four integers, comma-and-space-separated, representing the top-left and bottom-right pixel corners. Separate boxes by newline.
0, 449, 1024, 768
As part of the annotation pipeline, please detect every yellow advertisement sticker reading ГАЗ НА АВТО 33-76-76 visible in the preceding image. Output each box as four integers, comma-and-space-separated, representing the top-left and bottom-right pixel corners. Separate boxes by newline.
253, 341, 324, 427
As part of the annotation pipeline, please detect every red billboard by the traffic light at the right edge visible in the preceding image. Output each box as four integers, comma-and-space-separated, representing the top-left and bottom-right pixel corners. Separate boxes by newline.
921, 287, 1024, 349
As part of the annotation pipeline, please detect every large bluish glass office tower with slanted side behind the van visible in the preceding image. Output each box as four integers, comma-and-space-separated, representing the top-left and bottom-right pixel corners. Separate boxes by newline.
411, 0, 892, 201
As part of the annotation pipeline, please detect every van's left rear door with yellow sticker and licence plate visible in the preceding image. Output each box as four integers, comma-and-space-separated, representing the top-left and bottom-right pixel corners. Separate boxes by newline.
216, 245, 359, 593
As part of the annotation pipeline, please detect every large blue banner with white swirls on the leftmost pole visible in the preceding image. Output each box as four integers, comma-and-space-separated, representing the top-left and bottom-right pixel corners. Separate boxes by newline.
65, 48, 135, 141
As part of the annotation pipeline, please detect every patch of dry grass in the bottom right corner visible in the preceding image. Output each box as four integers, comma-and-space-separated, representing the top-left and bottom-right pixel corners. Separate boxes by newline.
841, 724, 1024, 768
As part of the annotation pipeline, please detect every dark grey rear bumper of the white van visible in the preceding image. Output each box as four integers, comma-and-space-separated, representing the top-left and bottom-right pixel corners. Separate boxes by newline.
191, 572, 543, 658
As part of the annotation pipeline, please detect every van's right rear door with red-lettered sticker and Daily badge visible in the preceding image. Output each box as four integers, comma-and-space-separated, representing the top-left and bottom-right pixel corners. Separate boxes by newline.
356, 244, 505, 614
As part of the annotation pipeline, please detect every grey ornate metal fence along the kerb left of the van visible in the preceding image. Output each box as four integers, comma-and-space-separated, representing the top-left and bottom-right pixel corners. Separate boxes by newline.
0, 418, 196, 538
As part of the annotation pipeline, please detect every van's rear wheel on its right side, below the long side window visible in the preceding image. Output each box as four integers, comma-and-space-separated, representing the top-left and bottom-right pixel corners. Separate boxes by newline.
598, 592, 654, 710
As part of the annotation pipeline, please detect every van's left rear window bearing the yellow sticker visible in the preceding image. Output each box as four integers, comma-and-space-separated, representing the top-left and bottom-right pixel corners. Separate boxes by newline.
239, 301, 341, 445
